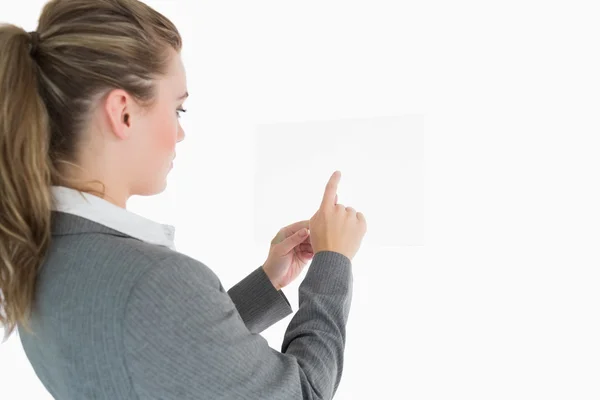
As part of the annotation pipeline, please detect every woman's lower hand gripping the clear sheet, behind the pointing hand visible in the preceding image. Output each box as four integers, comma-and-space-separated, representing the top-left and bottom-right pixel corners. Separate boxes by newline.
263, 220, 314, 290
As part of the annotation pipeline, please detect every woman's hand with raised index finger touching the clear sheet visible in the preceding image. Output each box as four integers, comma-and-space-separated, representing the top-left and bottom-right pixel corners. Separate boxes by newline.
308, 171, 367, 260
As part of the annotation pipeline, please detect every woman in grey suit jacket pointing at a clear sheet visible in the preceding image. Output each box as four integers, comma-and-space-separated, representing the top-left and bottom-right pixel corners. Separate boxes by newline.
0, 0, 366, 400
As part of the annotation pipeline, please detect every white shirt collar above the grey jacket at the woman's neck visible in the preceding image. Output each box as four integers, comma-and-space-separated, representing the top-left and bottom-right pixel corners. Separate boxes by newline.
51, 186, 176, 250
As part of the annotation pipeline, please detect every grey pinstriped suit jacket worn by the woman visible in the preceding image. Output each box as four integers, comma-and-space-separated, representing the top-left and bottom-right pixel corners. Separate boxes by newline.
18, 211, 353, 400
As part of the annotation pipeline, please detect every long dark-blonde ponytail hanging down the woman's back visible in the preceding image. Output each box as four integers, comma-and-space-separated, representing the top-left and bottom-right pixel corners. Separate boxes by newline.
0, 25, 51, 342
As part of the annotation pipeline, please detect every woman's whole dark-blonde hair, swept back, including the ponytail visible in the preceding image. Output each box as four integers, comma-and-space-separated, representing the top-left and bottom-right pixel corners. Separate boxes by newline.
0, 0, 182, 340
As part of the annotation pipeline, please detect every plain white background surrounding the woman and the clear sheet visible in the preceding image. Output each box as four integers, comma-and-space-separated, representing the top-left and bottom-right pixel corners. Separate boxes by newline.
0, 0, 600, 400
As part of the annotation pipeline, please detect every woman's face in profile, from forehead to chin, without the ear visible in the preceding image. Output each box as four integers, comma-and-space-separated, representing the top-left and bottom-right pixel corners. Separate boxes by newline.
128, 51, 187, 195
